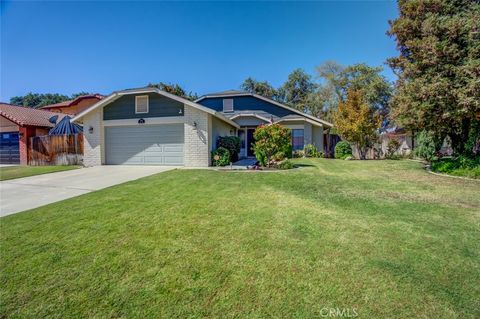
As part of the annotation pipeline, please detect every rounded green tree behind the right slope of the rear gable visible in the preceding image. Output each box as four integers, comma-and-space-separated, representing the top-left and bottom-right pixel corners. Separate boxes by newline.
278, 69, 315, 112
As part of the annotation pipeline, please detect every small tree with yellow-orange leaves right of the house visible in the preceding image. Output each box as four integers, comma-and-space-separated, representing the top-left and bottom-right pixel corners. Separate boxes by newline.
334, 89, 381, 159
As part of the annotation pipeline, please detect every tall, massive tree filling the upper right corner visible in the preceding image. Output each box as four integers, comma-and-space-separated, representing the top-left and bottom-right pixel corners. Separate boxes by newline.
387, 0, 480, 153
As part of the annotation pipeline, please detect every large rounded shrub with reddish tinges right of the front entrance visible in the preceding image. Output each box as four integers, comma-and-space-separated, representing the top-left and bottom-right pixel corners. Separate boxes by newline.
253, 124, 292, 167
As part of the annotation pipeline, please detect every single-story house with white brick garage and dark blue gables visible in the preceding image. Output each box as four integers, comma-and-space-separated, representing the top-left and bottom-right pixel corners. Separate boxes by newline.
72, 87, 332, 167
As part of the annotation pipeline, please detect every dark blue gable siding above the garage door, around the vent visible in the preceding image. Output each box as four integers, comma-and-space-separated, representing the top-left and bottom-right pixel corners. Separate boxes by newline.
103, 93, 184, 120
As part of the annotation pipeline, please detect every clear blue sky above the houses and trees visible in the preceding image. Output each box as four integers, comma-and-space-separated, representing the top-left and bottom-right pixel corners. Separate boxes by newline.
0, 0, 397, 101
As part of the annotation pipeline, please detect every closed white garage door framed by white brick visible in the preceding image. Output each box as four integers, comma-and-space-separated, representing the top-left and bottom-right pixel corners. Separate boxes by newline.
105, 123, 184, 165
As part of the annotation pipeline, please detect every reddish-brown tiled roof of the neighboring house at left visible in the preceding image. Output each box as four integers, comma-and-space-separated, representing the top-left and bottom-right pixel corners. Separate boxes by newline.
0, 103, 65, 127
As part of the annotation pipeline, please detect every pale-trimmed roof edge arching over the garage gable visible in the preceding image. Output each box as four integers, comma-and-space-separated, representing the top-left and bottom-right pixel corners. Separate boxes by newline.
72, 87, 240, 128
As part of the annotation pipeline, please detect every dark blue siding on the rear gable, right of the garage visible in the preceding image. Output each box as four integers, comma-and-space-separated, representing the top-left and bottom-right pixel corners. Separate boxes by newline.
198, 96, 295, 117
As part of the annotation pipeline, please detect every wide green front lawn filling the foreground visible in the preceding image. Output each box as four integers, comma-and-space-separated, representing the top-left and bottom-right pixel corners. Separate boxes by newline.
0, 159, 480, 318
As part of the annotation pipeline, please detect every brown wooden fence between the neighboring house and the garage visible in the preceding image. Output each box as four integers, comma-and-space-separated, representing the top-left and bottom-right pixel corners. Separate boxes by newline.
28, 134, 83, 166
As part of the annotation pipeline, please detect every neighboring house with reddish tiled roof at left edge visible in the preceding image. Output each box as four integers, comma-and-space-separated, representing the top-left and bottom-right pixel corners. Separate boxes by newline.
0, 103, 65, 165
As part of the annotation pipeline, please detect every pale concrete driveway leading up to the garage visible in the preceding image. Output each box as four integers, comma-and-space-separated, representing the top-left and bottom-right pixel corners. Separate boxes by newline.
0, 165, 175, 216
